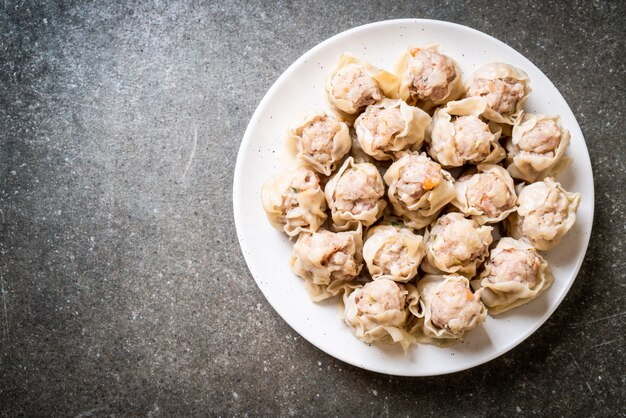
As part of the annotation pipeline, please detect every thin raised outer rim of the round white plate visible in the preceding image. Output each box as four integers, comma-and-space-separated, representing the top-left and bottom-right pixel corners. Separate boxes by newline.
232, 18, 595, 377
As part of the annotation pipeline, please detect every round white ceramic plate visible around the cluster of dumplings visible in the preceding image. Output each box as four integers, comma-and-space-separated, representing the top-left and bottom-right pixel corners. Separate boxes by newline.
233, 19, 594, 376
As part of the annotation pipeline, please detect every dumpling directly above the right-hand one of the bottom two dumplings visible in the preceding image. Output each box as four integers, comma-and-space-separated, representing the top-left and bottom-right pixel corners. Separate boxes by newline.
422, 212, 493, 277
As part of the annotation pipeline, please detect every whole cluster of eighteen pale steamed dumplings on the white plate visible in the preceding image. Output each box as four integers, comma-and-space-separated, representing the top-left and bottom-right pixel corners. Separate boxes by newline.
261, 45, 580, 349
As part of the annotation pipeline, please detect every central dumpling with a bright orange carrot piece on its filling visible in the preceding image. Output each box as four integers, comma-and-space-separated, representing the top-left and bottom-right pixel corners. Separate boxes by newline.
385, 152, 455, 229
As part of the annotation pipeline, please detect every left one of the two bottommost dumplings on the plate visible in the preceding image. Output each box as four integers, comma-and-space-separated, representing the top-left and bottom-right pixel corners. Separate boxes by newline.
343, 277, 418, 350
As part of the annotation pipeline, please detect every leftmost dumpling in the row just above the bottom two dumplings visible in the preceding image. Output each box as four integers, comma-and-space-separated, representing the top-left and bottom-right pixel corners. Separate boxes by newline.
290, 226, 363, 302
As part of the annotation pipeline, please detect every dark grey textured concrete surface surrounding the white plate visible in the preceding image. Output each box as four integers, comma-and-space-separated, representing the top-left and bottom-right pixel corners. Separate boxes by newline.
0, 0, 626, 417
